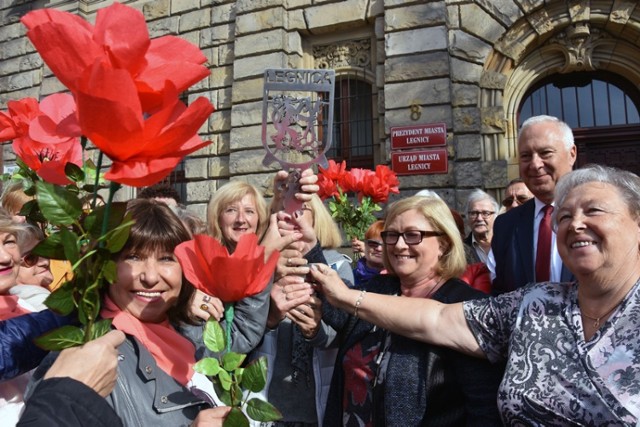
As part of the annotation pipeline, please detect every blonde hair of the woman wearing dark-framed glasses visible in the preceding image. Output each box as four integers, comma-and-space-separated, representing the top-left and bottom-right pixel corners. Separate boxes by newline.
382, 196, 467, 280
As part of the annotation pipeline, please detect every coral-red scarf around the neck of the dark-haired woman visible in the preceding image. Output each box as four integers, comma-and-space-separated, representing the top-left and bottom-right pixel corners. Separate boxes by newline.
100, 297, 196, 386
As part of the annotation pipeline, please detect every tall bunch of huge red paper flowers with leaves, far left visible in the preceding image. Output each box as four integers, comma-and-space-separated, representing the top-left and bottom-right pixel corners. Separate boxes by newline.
0, 3, 214, 350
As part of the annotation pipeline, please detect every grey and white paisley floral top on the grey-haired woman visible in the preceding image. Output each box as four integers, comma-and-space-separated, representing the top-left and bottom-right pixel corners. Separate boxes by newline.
464, 282, 640, 426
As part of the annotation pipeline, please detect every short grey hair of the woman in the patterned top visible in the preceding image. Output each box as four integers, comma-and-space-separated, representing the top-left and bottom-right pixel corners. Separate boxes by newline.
552, 165, 640, 224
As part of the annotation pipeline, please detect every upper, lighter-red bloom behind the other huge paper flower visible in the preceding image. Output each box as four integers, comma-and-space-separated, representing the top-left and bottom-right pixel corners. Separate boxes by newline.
21, 3, 209, 112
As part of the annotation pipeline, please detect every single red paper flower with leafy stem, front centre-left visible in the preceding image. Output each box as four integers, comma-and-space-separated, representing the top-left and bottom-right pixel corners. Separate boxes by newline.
175, 234, 282, 426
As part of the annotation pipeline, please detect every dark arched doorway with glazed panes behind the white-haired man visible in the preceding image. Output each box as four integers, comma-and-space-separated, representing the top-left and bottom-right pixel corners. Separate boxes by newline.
518, 71, 640, 174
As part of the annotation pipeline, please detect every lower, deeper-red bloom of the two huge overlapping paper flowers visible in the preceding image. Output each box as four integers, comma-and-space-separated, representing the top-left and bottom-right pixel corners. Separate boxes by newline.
76, 63, 213, 187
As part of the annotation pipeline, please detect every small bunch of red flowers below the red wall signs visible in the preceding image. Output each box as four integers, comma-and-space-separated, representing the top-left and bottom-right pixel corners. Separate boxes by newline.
318, 160, 400, 247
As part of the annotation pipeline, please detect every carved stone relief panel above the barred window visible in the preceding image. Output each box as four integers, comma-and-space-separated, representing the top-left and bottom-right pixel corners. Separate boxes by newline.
313, 38, 372, 70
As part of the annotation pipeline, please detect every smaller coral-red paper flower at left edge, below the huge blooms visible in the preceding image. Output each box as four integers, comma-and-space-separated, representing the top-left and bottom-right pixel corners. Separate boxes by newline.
0, 94, 82, 185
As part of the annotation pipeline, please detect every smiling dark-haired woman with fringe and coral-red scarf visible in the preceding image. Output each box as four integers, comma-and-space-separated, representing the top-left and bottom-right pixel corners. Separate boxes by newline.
26, 199, 235, 426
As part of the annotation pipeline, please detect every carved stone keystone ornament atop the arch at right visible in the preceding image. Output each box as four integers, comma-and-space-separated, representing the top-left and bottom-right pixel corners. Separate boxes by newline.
547, 22, 606, 73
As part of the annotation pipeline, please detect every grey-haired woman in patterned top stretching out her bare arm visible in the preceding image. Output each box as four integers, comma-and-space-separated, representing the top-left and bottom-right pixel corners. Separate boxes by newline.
314, 166, 640, 426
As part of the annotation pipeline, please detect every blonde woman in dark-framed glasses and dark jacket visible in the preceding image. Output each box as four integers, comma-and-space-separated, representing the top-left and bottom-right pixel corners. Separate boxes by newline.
312, 196, 502, 426
